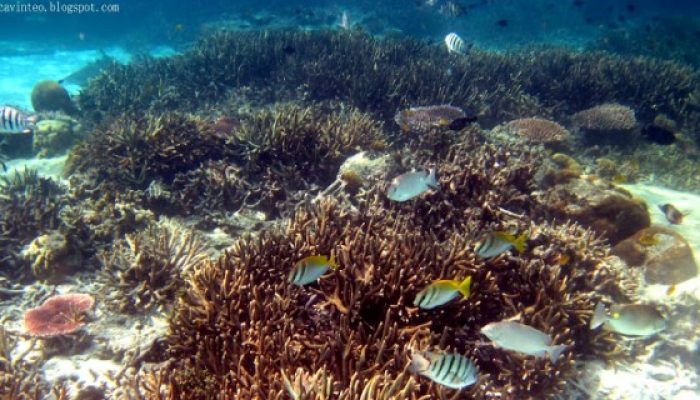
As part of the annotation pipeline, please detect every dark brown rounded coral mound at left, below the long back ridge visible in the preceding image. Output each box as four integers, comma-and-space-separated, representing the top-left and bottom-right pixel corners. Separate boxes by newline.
65, 113, 223, 189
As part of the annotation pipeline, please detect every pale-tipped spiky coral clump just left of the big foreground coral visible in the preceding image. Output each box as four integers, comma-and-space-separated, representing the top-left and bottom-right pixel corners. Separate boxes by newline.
100, 222, 207, 312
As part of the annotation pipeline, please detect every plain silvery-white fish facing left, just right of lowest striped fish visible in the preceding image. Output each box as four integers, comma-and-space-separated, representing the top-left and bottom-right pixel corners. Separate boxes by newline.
481, 321, 567, 362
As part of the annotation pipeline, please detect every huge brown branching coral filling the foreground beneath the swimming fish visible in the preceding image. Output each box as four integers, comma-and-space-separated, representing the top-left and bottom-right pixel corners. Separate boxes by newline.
156, 193, 632, 399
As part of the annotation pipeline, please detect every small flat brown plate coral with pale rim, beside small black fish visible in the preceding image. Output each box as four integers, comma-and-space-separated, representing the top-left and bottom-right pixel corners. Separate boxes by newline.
394, 104, 468, 133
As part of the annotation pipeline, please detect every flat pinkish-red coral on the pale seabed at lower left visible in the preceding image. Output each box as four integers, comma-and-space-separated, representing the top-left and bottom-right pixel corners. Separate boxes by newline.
24, 293, 95, 337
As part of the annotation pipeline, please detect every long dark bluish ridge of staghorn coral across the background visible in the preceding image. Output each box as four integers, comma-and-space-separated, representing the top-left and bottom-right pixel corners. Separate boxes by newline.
80, 31, 700, 131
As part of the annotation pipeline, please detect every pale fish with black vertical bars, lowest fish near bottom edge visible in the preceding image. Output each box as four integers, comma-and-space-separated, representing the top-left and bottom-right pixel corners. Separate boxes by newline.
410, 351, 479, 389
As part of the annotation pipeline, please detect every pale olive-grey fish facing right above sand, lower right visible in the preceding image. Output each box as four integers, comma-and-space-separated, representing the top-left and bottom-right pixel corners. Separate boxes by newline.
591, 303, 666, 336
